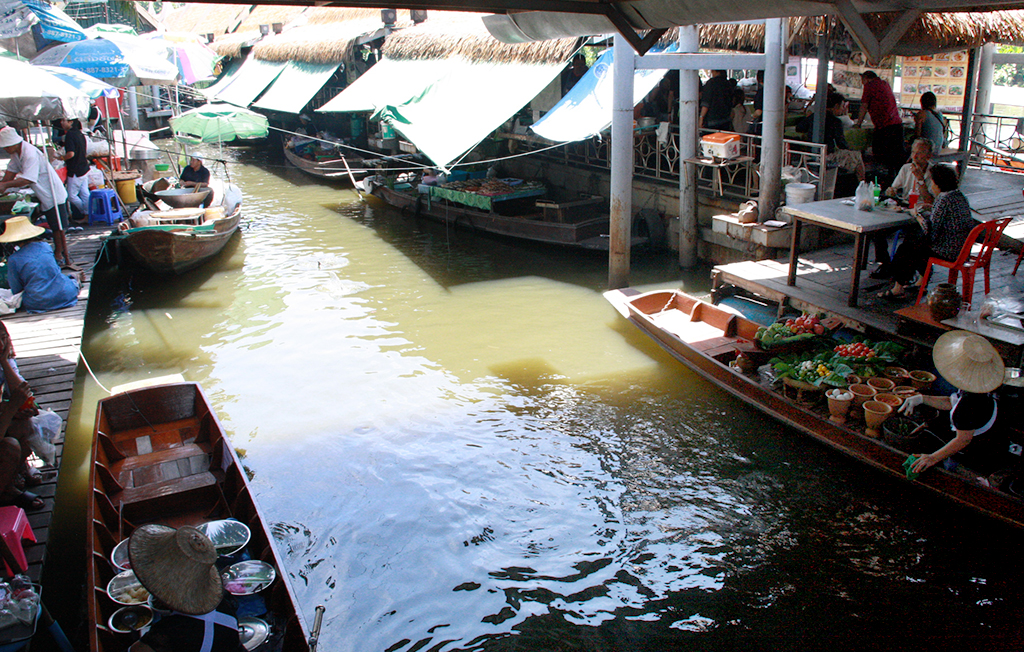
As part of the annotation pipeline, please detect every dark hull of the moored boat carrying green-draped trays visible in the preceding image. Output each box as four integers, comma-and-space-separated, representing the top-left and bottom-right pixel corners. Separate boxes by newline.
372, 185, 647, 251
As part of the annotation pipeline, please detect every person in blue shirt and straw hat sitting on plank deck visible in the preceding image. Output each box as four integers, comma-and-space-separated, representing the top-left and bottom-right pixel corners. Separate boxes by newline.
0, 216, 85, 312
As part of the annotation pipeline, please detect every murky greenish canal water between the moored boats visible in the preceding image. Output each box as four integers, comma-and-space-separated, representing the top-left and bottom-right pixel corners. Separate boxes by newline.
48, 149, 1024, 652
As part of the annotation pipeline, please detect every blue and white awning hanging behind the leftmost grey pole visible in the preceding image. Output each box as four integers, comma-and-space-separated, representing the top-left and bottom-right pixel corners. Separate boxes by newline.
530, 44, 678, 142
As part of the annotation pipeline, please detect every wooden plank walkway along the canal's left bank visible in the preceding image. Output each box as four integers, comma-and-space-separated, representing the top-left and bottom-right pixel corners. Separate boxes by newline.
2, 225, 111, 581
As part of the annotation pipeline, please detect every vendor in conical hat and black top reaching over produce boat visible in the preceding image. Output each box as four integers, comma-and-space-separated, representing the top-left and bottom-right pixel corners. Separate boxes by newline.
900, 331, 1011, 476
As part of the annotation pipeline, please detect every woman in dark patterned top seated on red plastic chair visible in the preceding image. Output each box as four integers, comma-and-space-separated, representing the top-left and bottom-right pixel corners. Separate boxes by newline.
879, 165, 978, 299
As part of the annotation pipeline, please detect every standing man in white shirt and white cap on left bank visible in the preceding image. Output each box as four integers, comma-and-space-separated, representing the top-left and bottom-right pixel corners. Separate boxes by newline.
0, 126, 78, 270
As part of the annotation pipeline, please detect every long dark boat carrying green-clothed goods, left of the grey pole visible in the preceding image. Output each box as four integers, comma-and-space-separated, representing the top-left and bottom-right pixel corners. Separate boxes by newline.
361, 177, 647, 252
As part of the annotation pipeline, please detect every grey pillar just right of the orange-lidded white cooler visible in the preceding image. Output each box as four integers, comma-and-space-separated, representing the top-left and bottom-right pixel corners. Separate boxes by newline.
758, 18, 786, 221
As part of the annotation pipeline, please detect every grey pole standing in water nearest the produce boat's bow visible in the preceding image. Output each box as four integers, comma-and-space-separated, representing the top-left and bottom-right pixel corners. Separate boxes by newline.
608, 34, 634, 290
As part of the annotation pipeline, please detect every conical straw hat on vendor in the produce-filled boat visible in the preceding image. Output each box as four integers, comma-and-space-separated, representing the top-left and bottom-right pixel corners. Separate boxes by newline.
932, 331, 1005, 394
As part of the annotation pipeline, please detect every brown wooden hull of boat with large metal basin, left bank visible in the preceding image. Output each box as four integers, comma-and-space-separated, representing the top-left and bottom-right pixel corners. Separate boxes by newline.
119, 207, 242, 274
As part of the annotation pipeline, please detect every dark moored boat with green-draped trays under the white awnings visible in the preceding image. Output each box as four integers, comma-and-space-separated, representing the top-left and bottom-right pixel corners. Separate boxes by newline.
360, 176, 647, 251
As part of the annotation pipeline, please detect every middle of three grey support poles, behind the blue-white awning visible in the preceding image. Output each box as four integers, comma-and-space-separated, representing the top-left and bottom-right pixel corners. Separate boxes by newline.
679, 25, 700, 268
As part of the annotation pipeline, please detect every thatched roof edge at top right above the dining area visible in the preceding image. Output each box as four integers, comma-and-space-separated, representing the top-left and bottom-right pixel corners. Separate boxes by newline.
700, 11, 1024, 55
